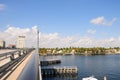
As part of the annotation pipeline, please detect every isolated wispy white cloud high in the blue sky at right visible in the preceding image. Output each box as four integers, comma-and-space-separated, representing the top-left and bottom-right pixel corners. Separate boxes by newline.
90, 16, 117, 26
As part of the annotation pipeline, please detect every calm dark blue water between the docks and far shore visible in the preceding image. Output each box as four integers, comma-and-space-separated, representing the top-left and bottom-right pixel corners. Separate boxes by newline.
41, 55, 120, 80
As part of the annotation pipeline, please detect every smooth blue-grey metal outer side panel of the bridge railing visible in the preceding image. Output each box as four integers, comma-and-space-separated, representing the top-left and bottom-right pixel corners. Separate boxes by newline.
17, 50, 41, 80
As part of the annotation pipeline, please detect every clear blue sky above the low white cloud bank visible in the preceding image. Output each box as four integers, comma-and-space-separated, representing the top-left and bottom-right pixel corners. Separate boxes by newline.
0, 0, 120, 47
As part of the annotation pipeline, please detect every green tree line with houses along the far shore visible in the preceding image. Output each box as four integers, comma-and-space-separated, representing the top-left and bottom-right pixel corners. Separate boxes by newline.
39, 47, 120, 55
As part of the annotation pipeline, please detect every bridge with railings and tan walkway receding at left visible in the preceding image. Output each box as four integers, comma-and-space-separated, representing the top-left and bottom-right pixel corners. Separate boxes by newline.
0, 48, 42, 80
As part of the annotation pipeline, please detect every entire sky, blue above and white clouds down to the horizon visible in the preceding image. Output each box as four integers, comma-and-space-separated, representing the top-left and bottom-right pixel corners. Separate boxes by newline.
0, 0, 120, 47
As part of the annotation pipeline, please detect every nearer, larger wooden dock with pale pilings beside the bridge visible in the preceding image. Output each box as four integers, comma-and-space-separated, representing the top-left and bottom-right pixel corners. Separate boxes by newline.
41, 66, 78, 77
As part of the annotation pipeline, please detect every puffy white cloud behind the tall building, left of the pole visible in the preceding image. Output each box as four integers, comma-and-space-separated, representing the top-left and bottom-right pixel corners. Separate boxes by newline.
0, 26, 36, 46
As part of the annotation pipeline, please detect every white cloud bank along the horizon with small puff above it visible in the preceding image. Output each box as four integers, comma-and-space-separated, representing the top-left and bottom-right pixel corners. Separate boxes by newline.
0, 26, 120, 48
